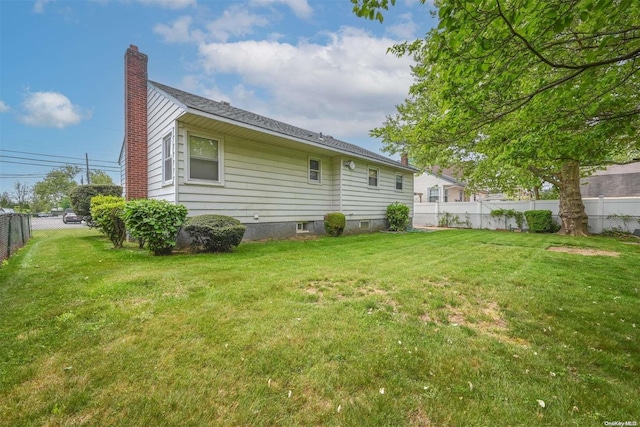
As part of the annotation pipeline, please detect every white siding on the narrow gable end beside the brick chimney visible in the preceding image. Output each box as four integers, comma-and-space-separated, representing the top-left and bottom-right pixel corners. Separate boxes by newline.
147, 88, 184, 201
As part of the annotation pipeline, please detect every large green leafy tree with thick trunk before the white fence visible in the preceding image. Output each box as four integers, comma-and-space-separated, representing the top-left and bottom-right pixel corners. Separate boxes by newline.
352, 0, 640, 235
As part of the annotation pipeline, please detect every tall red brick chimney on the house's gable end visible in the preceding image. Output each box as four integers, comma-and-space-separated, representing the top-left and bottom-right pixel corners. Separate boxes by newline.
124, 45, 149, 200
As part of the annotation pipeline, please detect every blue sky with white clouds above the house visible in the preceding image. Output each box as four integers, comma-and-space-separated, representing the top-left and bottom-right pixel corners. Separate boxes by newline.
0, 0, 435, 194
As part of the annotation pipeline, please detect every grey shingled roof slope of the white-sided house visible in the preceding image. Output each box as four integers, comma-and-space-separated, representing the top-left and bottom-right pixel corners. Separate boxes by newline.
149, 81, 417, 172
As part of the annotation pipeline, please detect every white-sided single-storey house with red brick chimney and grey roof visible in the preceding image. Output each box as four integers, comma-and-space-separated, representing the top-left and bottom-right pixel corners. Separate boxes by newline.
120, 45, 417, 240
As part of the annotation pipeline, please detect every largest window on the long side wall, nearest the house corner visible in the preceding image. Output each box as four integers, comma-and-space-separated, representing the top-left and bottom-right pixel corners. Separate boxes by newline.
188, 134, 222, 183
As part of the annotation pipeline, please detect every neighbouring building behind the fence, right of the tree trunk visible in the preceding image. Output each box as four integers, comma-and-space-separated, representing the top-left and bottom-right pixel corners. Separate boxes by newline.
580, 161, 640, 197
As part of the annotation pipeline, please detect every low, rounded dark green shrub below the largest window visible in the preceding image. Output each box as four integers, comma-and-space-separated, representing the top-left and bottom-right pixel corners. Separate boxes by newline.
184, 215, 247, 252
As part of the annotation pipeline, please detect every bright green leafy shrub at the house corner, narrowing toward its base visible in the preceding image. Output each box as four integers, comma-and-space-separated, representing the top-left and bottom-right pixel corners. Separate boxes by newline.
122, 199, 187, 255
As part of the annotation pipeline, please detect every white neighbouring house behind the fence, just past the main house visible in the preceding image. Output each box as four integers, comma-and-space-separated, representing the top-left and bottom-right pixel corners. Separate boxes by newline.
414, 169, 470, 203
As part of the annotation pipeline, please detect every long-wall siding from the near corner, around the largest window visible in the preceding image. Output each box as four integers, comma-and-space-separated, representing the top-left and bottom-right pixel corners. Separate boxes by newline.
178, 119, 333, 223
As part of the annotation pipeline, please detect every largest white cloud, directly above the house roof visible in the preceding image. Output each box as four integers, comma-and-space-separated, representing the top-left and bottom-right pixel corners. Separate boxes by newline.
199, 27, 412, 138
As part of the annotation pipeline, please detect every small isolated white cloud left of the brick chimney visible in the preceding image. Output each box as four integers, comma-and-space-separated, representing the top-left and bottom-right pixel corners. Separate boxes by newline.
20, 92, 88, 129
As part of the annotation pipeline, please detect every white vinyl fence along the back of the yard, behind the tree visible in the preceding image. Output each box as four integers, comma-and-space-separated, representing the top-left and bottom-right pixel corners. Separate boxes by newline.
413, 197, 640, 234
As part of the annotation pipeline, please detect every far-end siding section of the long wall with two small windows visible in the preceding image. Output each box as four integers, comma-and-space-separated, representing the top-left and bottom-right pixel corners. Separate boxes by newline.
342, 161, 413, 220
